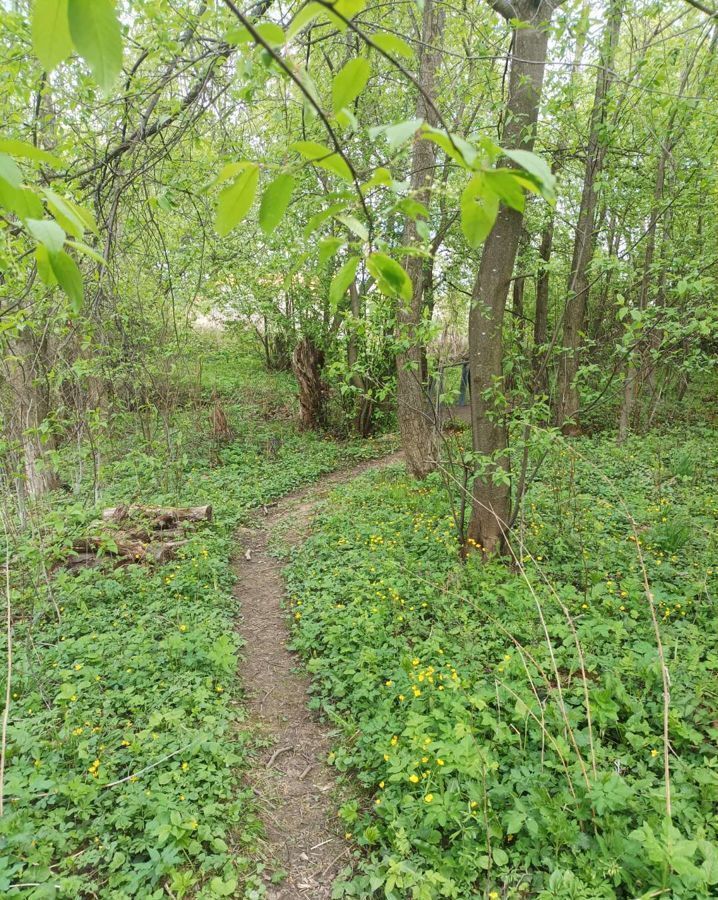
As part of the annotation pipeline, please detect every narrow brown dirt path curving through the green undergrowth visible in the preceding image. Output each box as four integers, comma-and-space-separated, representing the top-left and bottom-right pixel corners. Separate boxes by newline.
235, 453, 400, 900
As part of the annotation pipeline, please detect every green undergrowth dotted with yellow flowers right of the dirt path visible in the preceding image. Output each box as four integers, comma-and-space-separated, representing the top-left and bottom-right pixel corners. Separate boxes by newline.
288, 428, 718, 900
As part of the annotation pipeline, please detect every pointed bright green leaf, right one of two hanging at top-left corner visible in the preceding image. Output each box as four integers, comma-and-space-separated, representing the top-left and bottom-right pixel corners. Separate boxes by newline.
68, 0, 122, 93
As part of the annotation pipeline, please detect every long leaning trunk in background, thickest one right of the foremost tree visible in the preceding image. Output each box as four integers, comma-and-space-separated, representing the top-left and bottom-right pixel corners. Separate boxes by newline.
556, 0, 623, 434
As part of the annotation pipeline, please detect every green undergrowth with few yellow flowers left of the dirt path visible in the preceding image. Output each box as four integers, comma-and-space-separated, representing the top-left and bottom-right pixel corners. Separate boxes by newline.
0, 342, 391, 900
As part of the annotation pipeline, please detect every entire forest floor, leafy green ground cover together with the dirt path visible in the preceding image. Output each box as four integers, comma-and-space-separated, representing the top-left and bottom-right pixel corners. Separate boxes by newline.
0, 343, 718, 900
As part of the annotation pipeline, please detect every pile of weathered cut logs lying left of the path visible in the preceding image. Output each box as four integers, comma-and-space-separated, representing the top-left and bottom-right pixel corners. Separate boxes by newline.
54, 506, 212, 571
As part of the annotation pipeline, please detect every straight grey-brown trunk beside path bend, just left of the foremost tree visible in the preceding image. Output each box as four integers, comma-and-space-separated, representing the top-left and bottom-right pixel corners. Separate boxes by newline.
396, 0, 444, 478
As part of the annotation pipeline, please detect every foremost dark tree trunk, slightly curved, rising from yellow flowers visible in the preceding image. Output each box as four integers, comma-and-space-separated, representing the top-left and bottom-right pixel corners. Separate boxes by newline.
468, 0, 558, 555
